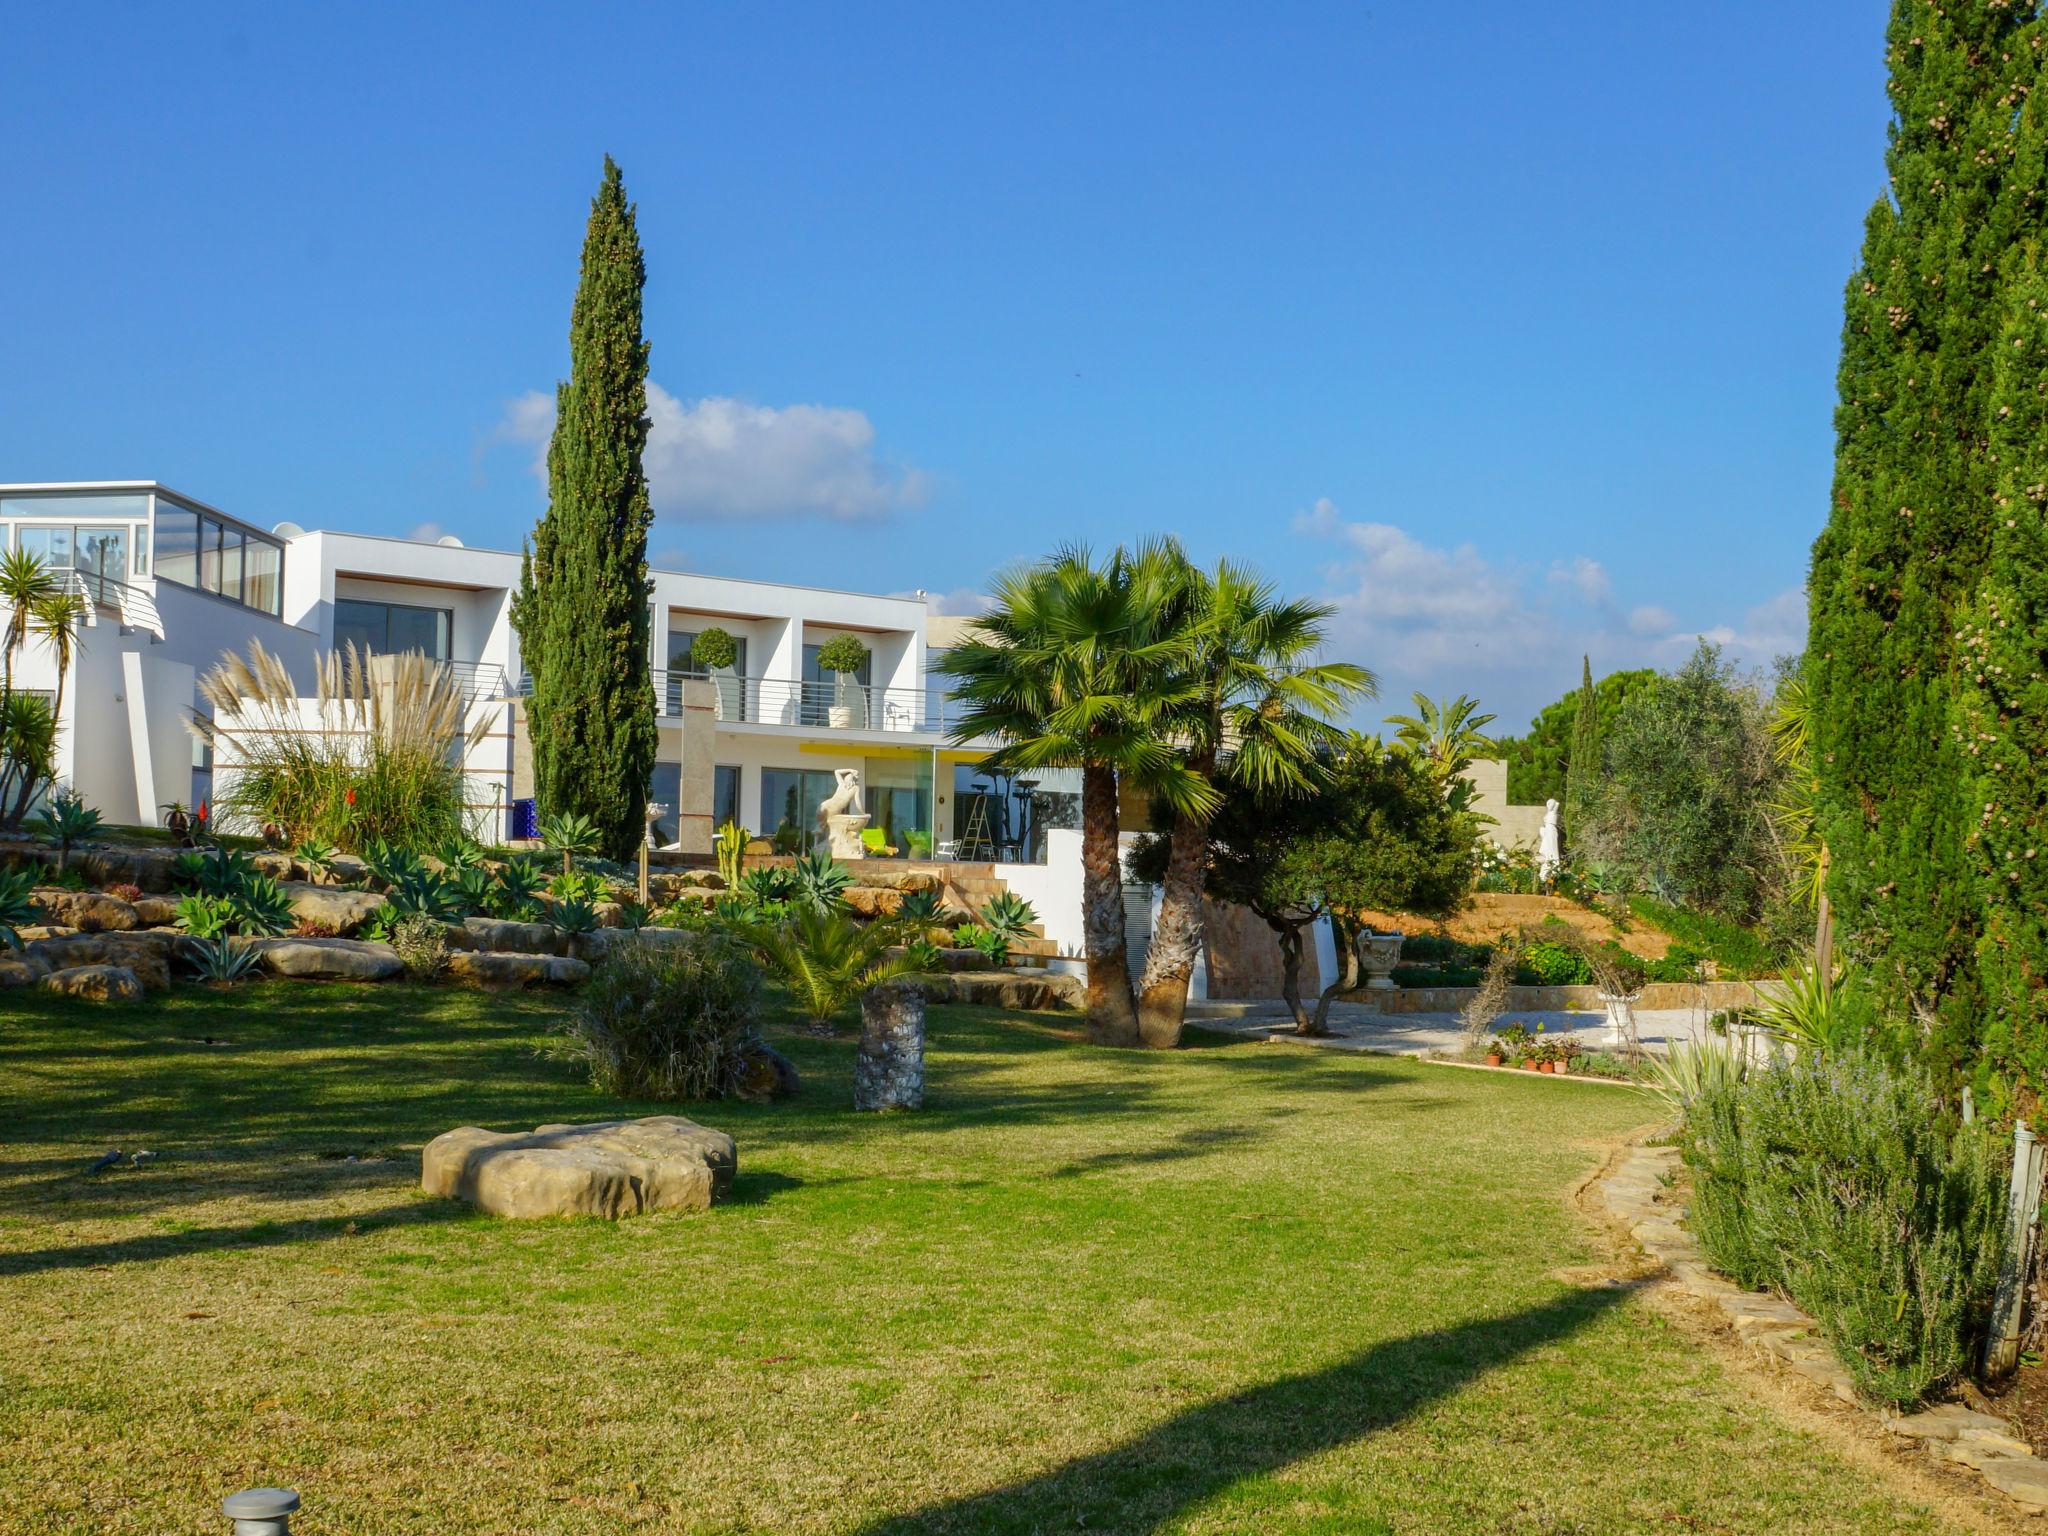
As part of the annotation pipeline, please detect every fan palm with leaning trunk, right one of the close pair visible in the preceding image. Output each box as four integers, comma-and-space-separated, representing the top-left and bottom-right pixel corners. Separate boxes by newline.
1139, 545, 1378, 1049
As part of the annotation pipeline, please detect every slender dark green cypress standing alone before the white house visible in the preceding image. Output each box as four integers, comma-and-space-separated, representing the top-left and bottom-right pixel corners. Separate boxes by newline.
512, 156, 655, 858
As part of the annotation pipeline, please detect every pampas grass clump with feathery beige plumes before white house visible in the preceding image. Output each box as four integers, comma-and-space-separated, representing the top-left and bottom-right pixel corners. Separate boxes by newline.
186, 643, 496, 850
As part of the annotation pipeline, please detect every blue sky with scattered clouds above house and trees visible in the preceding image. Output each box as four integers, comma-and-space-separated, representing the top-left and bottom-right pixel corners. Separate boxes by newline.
0, 0, 1884, 723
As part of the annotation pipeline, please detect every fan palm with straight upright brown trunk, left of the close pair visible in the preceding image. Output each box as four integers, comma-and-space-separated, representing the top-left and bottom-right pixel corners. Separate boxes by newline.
942, 543, 1217, 1044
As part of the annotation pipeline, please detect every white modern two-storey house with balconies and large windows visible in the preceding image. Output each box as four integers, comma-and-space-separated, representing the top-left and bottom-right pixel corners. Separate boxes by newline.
0, 481, 1077, 888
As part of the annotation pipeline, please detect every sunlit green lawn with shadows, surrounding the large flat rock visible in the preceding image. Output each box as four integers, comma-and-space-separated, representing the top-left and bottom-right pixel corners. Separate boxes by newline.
0, 983, 1950, 1536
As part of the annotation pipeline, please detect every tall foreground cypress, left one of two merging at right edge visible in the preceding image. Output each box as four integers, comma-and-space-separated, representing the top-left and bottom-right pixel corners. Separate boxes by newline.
1806, 0, 2042, 1069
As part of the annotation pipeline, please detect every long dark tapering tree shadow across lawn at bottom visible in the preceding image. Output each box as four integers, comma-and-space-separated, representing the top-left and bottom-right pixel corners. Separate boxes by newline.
860, 1288, 1628, 1536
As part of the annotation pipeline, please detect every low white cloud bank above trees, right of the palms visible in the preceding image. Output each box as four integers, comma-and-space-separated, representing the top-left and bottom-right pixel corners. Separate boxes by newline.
1294, 498, 1806, 731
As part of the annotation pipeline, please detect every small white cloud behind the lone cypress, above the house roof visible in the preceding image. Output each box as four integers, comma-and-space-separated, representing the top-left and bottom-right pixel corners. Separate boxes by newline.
496, 381, 930, 522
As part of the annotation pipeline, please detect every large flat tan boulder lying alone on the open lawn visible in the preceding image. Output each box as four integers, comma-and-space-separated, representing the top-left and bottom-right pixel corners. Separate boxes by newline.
420, 1114, 739, 1219
